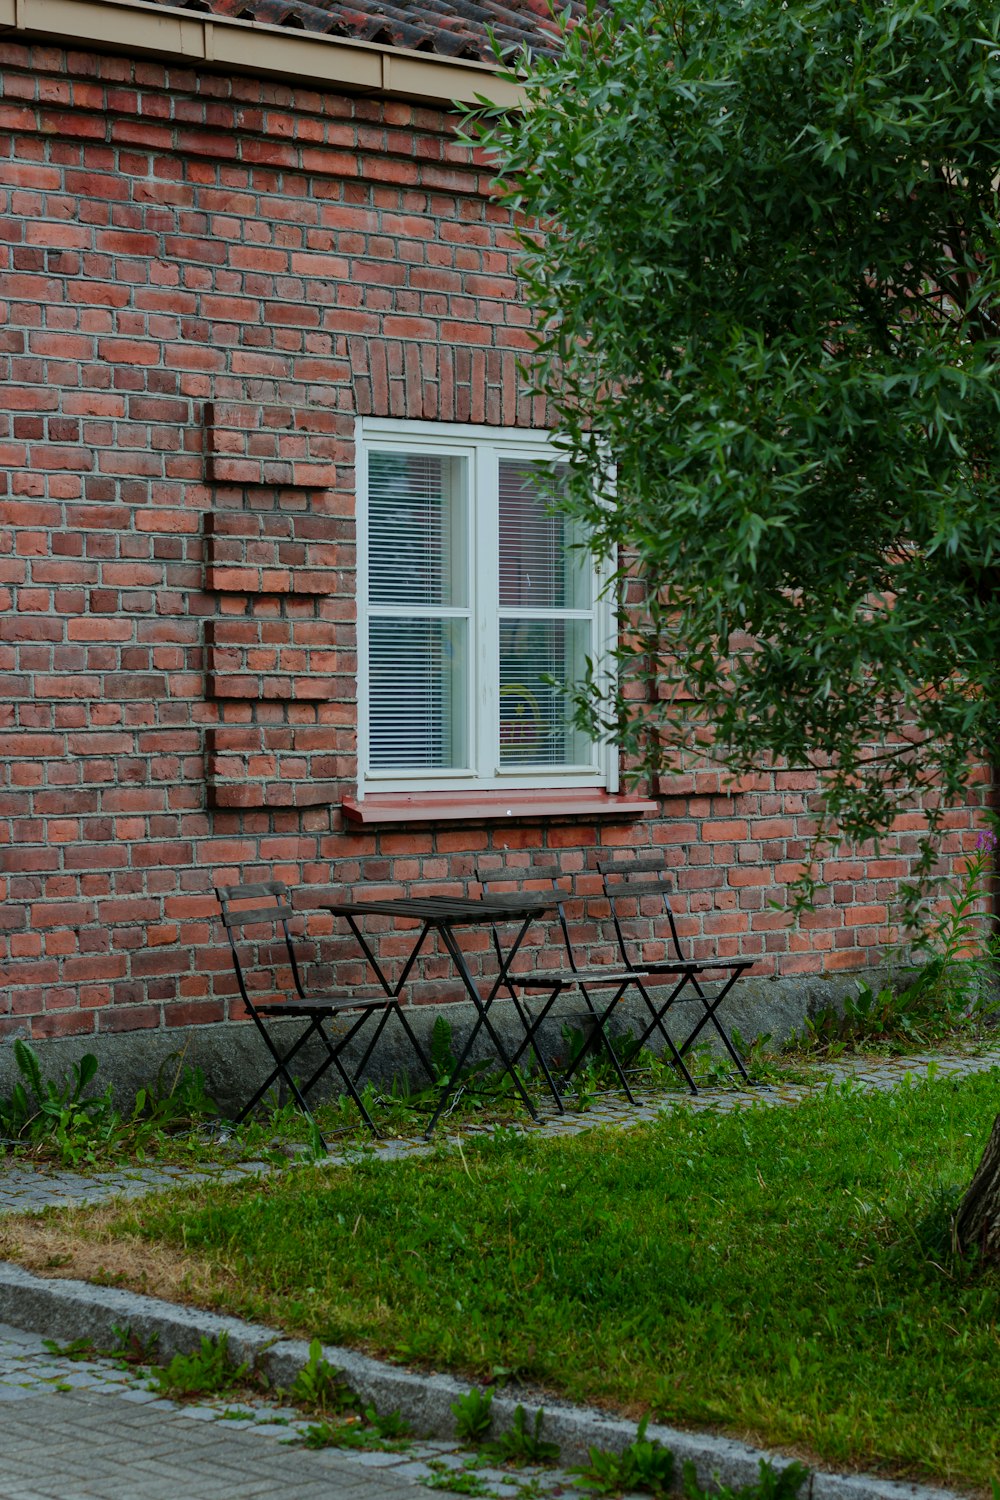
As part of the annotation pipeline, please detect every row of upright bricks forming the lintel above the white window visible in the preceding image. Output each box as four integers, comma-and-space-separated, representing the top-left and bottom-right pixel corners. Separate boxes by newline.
348, 338, 550, 428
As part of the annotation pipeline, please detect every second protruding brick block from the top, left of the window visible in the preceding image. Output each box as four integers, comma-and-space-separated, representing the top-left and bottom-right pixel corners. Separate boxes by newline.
205, 510, 347, 594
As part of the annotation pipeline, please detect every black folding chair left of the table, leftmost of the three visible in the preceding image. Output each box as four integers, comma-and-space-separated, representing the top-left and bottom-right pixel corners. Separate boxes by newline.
216, 881, 433, 1151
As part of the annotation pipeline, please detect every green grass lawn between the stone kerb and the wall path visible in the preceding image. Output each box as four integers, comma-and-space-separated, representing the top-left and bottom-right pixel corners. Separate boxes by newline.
83, 1070, 1000, 1485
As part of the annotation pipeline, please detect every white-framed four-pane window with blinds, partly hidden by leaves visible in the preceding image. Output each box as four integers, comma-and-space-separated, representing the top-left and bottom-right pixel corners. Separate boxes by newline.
357, 419, 618, 797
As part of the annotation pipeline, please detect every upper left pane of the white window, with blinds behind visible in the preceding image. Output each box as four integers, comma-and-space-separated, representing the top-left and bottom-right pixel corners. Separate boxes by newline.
369, 453, 466, 606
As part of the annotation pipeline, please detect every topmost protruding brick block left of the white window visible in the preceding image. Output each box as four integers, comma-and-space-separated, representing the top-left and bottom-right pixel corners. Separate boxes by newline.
205, 401, 342, 489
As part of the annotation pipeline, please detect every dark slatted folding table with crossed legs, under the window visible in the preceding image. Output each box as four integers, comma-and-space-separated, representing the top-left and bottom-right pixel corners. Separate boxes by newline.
322, 891, 562, 1137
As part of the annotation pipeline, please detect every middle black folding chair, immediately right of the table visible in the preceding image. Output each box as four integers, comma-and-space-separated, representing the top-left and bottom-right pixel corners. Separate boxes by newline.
477, 867, 697, 1110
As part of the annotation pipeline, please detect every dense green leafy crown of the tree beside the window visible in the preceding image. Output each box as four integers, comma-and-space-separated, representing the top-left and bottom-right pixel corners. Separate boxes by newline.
471, 0, 1000, 887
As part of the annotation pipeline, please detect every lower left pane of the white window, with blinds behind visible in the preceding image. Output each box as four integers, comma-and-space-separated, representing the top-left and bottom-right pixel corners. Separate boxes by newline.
369, 618, 468, 770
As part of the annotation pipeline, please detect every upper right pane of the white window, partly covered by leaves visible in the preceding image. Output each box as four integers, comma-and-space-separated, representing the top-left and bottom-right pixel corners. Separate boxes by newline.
499, 459, 591, 609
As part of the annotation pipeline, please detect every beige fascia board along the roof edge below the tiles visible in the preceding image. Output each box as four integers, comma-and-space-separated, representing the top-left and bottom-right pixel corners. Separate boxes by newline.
0, 0, 523, 107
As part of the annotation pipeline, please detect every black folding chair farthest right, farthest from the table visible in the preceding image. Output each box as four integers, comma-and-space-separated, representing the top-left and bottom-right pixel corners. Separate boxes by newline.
598, 855, 754, 1083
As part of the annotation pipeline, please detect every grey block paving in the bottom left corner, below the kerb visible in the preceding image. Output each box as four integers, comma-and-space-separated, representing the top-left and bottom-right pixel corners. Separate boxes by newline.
0, 1325, 583, 1500
